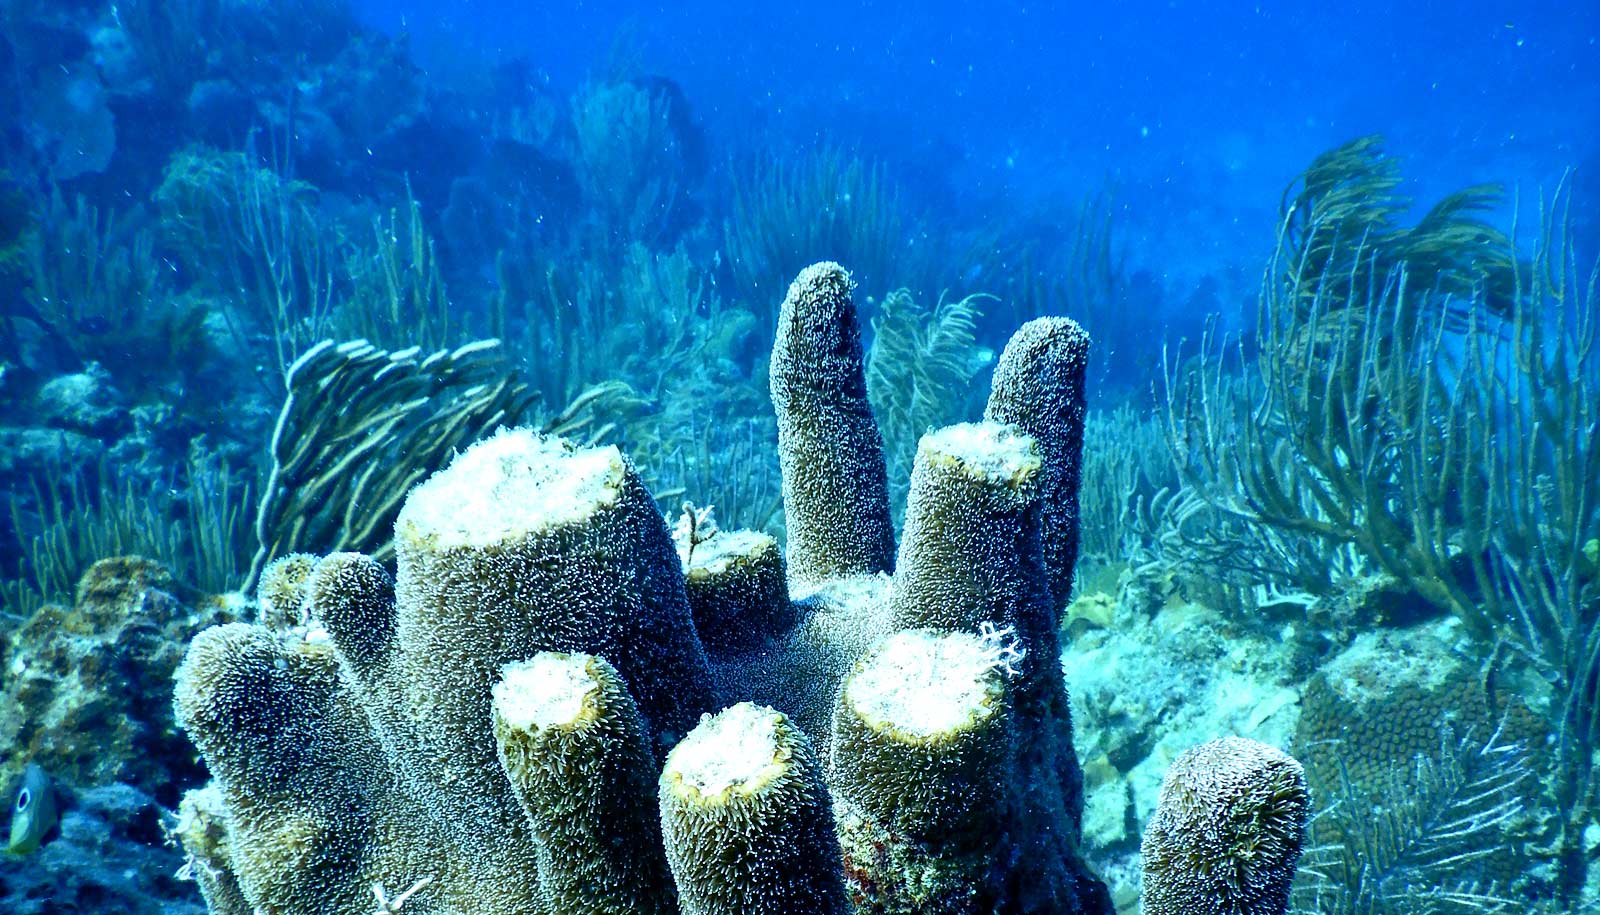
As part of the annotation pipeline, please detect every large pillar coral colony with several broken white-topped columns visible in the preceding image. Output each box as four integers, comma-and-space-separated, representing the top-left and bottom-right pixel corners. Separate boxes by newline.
176, 264, 1298, 915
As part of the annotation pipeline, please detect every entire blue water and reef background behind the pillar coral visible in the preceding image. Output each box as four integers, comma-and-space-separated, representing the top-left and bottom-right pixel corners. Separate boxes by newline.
0, 0, 1600, 915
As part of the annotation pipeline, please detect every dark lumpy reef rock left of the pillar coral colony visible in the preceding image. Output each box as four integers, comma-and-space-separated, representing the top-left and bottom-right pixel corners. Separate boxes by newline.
0, 557, 228, 915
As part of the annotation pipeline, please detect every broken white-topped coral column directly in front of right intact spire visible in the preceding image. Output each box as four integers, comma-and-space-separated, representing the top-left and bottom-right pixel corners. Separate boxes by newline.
876, 415, 1104, 912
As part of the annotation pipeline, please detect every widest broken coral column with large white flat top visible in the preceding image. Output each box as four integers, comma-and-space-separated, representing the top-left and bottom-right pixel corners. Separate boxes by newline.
380, 429, 710, 806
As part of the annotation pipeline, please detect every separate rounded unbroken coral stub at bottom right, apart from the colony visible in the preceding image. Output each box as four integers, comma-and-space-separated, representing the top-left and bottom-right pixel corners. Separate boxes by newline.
1141, 737, 1310, 915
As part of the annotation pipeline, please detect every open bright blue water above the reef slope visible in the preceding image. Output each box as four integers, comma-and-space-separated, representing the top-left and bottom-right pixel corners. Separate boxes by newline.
360, 0, 1600, 288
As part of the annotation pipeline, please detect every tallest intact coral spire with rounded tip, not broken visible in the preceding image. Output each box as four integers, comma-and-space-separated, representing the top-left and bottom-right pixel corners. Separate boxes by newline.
771, 262, 894, 582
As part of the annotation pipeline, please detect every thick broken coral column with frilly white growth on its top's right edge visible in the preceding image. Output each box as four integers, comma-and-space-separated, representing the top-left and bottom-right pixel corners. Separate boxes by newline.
829, 629, 1014, 915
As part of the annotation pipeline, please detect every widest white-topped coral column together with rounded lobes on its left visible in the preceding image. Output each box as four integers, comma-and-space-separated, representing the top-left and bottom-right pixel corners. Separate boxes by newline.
178, 430, 710, 912
